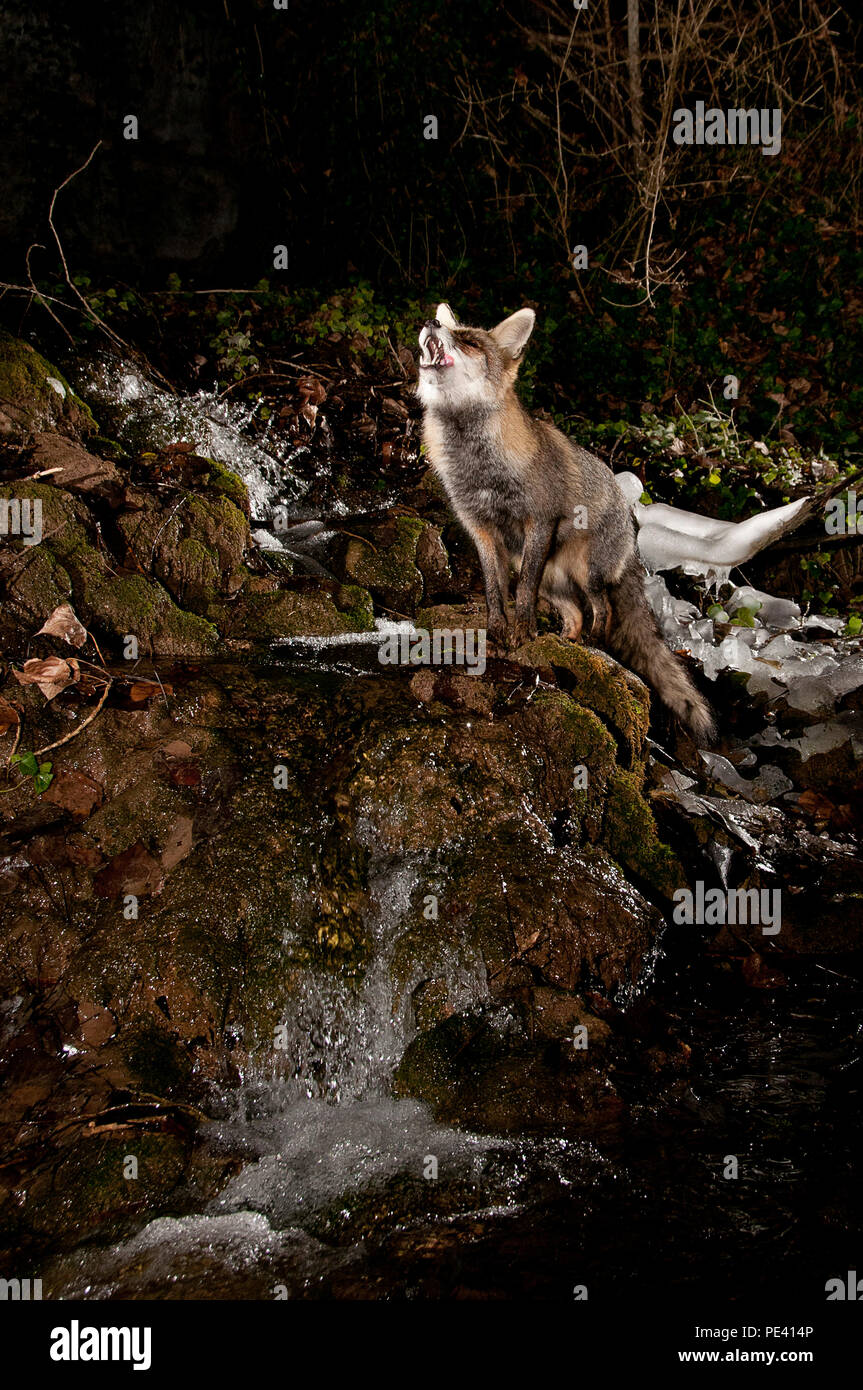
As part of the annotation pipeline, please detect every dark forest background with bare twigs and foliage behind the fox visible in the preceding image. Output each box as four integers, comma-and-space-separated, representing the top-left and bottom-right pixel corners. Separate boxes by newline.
0, 0, 863, 453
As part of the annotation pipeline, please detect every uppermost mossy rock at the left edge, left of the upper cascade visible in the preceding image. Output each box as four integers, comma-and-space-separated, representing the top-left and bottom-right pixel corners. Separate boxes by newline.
0, 332, 97, 442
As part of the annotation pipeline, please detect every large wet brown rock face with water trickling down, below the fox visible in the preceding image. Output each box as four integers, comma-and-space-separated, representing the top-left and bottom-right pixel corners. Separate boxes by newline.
0, 656, 680, 1247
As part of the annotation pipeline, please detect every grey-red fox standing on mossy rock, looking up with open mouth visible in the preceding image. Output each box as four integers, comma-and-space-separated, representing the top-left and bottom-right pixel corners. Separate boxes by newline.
418, 304, 714, 741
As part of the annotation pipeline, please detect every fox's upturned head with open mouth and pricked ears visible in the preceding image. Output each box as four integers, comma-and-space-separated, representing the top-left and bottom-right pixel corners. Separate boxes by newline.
418, 304, 536, 410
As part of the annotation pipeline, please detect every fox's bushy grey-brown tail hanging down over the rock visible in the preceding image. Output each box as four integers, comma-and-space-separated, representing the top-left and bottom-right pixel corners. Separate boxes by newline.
609, 559, 716, 744
